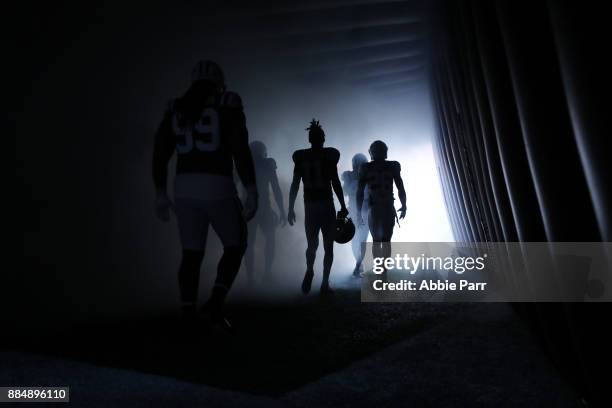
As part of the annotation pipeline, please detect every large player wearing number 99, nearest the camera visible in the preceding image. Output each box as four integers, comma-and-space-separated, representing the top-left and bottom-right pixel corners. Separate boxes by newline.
153, 61, 257, 328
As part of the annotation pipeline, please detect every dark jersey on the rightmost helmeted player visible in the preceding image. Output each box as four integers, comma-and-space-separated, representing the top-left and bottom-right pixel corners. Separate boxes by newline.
359, 160, 401, 205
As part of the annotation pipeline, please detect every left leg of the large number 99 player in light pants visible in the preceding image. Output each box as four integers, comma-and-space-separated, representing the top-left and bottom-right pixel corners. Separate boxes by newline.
174, 199, 208, 317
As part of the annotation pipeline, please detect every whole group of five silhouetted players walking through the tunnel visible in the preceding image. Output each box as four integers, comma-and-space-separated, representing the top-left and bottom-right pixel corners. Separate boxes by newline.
153, 61, 406, 330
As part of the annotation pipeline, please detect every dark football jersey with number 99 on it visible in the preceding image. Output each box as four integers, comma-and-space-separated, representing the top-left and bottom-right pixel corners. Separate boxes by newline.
153, 92, 255, 199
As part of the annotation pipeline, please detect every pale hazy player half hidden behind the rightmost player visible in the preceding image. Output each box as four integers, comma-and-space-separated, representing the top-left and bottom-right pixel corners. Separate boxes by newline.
342, 153, 369, 276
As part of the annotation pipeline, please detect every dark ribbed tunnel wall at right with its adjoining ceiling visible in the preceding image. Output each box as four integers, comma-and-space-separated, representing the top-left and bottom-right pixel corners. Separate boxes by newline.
246, 1, 612, 406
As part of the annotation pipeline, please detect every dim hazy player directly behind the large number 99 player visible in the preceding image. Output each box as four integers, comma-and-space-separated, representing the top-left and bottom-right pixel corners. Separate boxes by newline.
245, 141, 287, 283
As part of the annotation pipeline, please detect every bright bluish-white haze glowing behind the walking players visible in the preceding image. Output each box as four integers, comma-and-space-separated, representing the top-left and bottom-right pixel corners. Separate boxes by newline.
210, 67, 454, 286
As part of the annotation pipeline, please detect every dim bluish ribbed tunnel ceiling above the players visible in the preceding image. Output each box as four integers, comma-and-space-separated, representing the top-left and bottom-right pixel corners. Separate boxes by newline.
210, 0, 430, 95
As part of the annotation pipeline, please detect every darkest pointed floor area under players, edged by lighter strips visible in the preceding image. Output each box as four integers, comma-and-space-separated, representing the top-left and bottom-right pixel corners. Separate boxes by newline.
3, 290, 466, 395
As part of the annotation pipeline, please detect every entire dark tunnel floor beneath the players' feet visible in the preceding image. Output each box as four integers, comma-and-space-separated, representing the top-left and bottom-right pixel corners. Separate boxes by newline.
0, 290, 580, 407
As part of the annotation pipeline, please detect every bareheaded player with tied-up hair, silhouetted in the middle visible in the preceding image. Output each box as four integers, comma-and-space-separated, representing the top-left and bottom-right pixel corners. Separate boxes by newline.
287, 119, 348, 294
